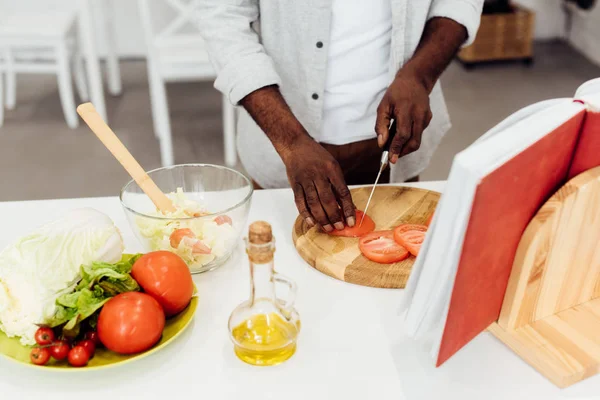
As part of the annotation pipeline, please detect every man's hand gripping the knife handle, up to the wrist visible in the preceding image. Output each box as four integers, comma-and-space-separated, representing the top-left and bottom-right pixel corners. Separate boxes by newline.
375, 69, 432, 164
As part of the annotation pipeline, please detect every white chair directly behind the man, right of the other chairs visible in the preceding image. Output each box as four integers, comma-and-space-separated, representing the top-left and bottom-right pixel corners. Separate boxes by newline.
138, 0, 237, 166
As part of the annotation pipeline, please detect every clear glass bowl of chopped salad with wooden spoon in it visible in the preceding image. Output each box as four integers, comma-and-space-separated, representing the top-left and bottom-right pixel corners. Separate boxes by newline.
120, 164, 254, 273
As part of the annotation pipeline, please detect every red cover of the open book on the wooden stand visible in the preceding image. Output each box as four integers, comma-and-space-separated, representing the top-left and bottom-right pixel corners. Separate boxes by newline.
437, 111, 584, 366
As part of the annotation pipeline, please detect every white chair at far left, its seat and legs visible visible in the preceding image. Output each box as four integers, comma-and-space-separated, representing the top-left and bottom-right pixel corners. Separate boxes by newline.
0, 9, 89, 128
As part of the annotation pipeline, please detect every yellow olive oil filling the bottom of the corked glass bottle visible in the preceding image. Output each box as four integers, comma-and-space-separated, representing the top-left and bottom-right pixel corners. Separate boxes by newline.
232, 313, 298, 366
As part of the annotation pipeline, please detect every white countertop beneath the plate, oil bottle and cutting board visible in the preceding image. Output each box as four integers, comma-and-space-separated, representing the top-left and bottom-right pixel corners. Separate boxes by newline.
0, 182, 600, 400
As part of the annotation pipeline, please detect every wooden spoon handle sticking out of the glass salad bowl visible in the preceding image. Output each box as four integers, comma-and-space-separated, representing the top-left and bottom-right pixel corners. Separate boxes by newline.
77, 103, 175, 214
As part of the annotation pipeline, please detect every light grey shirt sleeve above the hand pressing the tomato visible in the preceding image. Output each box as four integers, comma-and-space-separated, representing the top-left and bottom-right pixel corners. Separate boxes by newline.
196, 0, 281, 105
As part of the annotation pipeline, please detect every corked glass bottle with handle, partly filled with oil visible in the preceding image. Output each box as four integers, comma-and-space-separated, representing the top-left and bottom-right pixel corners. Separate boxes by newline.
229, 221, 300, 366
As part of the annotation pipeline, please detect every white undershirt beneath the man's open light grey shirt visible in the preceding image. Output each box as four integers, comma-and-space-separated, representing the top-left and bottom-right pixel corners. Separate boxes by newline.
319, 0, 392, 145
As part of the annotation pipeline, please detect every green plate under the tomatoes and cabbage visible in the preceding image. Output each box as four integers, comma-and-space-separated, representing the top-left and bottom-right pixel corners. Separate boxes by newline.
0, 294, 198, 371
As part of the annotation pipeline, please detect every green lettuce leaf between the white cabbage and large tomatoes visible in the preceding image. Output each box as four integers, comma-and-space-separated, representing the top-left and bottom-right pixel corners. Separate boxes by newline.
47, 254, 142, 337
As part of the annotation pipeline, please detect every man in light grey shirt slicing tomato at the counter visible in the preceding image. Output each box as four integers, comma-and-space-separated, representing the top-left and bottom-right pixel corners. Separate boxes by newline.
198, 0, 484, 232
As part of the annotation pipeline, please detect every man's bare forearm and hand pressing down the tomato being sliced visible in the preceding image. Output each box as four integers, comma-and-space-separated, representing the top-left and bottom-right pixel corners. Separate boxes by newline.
241, 86, 356, 232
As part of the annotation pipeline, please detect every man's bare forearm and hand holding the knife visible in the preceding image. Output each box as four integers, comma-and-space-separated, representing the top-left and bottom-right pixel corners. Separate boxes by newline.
375, 18, 467, 163
